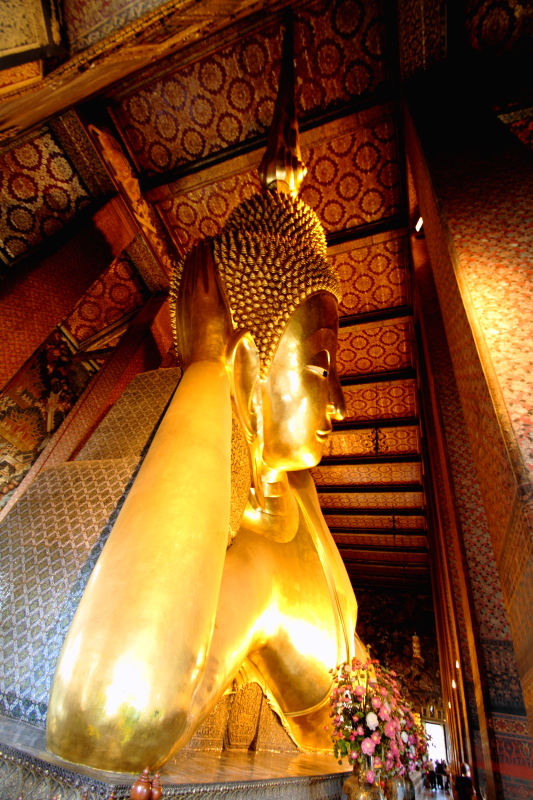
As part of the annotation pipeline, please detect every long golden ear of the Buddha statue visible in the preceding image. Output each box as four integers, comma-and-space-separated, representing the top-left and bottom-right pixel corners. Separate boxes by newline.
226, 330, 265, 507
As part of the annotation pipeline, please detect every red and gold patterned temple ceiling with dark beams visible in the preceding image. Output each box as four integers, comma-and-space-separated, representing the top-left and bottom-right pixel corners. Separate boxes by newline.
0, 0, 529, 588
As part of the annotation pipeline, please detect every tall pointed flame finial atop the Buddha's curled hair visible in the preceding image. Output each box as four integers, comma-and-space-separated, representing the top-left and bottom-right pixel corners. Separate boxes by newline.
259, 9, 307, 197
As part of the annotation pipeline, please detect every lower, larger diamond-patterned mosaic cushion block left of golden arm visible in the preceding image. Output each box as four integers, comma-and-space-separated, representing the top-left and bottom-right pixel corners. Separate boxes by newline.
0, 458, 138, 726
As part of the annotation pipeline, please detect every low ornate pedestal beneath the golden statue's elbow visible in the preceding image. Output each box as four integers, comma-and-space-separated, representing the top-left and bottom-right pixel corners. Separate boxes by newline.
0, 717, 350, 800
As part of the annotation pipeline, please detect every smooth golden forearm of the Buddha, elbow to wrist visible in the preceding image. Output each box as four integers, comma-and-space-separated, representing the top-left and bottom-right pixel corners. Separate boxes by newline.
47, 361, 231, 770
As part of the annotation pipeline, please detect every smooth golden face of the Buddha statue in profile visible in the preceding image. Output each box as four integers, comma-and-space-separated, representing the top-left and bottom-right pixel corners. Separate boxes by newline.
262, 292, 346, 470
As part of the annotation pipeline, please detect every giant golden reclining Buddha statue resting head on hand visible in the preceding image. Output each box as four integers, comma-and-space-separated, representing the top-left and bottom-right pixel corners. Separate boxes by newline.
47, 28, 364, 771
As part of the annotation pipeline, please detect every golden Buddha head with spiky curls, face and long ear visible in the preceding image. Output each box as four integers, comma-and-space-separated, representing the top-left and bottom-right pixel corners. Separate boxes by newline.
168, 190, 345, 534
